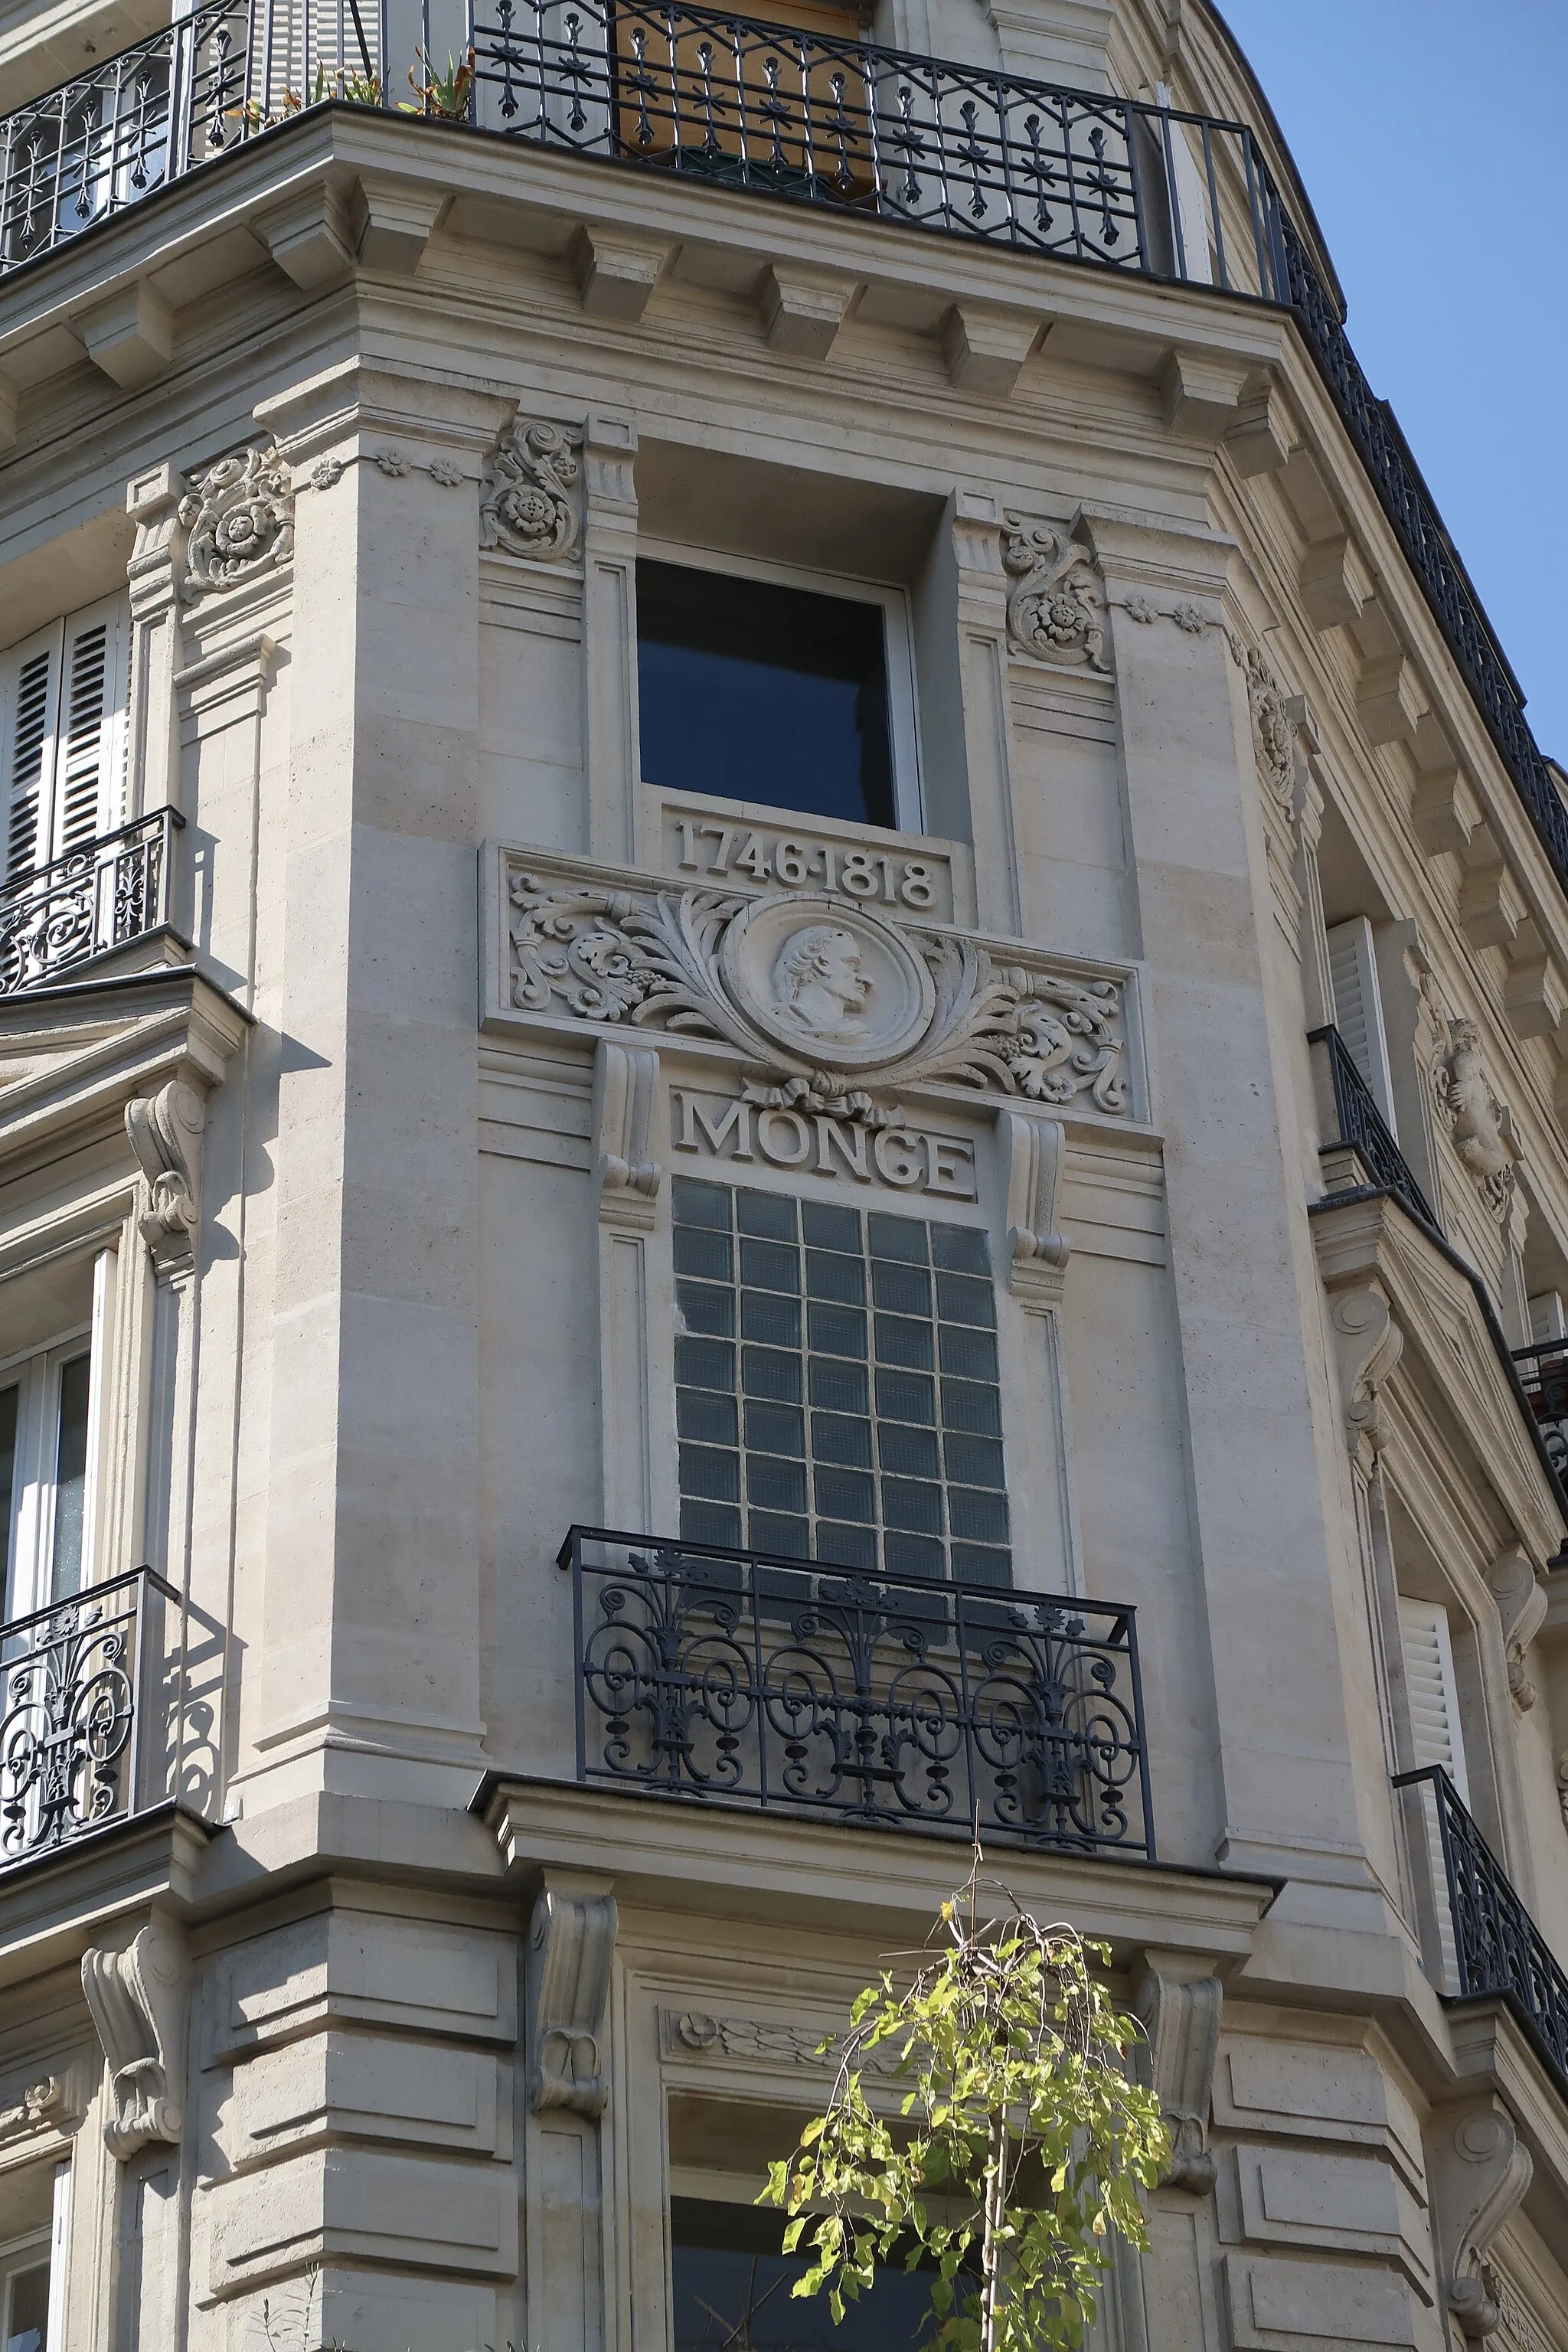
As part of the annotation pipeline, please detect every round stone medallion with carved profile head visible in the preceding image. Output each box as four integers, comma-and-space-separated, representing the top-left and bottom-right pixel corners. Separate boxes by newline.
720, 891, 936, 1070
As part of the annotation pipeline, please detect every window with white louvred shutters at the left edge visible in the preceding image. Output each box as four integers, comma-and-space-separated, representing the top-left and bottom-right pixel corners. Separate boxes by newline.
0, 597, 129, 880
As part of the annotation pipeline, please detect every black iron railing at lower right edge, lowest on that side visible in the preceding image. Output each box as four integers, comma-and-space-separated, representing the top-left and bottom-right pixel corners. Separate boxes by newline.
1394, 1764, 1568, 2098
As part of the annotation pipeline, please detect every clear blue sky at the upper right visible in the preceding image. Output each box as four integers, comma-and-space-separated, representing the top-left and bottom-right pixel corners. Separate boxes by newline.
1220, 0, 1568, 764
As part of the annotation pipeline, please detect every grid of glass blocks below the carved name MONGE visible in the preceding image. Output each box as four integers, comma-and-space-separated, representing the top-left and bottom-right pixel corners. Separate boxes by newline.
675, 1176, 1011, 1586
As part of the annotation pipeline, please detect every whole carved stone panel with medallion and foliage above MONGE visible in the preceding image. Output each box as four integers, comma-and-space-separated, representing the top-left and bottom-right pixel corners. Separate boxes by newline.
505, 868, 1129, 1115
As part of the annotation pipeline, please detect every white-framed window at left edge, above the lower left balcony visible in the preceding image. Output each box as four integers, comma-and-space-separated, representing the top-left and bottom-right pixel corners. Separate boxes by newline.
0, 1334, 92, 1619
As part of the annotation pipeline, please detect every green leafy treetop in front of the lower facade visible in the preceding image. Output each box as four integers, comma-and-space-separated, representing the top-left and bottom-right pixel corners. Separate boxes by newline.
760, 1854, 1171, 2352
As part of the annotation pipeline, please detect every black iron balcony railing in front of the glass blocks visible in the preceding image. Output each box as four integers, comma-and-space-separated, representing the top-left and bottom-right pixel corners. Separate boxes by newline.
560, 1527, 1155, 1860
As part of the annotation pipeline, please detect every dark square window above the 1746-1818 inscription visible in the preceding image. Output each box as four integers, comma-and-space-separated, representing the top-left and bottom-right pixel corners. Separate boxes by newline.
637, 560, 920, 830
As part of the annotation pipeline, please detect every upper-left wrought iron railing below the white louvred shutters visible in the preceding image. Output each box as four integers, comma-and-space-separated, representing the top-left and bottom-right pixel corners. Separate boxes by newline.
0, 809, 186, 998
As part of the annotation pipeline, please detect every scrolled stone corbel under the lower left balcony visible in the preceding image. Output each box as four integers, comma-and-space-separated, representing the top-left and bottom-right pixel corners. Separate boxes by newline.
82, 1919, 191, 2159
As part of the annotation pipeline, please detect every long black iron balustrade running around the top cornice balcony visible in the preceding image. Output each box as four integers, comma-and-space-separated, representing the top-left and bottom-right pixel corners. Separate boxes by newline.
0, 0, 1568, 936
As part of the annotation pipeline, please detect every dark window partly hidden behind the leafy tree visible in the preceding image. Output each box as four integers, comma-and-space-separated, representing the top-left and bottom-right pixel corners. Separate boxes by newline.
670, 2197, 931, 2352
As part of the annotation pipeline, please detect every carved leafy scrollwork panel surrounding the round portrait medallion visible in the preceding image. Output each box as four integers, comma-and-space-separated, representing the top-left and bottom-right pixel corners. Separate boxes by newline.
508, 873, 1129, 1124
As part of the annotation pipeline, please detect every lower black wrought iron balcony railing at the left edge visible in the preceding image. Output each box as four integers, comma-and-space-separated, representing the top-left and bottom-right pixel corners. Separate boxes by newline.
0, 1569, 224, 1865
